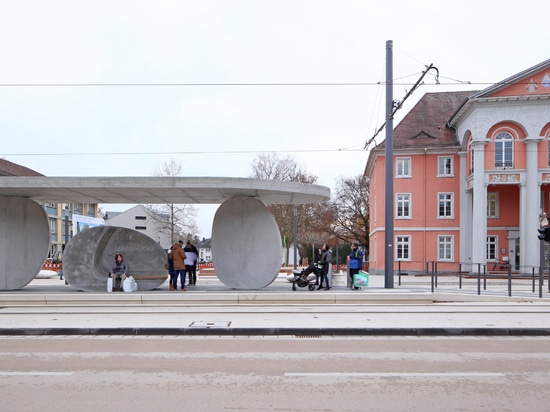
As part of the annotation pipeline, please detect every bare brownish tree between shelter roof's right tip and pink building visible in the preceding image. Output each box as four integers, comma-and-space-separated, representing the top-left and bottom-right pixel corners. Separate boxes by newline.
330, 175, 370, 250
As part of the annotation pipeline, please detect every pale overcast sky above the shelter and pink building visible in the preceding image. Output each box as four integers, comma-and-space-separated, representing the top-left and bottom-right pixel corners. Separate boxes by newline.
0, 0, 550, 237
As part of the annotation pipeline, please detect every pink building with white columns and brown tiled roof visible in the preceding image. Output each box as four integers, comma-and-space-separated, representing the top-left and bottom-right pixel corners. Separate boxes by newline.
365, 60, 550, 274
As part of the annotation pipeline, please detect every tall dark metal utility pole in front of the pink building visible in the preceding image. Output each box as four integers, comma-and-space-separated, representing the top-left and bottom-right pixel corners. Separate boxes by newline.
384, 40, 394, 289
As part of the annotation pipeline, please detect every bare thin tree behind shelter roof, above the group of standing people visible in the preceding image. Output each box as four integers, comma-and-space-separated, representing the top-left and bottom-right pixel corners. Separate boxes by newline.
146, 158, 198, 244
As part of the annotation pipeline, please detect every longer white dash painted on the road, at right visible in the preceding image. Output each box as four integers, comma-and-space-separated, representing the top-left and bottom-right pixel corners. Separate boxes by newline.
285, 372, 506, 378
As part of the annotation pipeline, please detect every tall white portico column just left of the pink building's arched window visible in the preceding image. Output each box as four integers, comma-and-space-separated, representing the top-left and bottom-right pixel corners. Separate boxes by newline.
471, 142, 487, 269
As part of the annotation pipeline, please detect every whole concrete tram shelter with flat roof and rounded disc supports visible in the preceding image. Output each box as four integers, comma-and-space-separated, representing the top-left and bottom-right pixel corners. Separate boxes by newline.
0, 176, 330, 291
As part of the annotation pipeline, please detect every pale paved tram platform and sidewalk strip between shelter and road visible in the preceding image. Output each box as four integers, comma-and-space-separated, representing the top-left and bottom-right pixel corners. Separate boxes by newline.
0, 276, 550, 336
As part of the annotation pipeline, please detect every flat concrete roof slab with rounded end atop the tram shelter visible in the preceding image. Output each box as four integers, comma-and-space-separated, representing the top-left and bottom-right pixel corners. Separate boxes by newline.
0, 176, 330, 204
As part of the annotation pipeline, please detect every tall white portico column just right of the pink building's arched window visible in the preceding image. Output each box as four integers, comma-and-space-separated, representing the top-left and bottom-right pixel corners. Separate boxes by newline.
519, 138, 541, 273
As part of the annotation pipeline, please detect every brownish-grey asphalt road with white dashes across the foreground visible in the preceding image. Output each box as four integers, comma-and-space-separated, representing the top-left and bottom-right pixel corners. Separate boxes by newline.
0, 336, 550, 412
